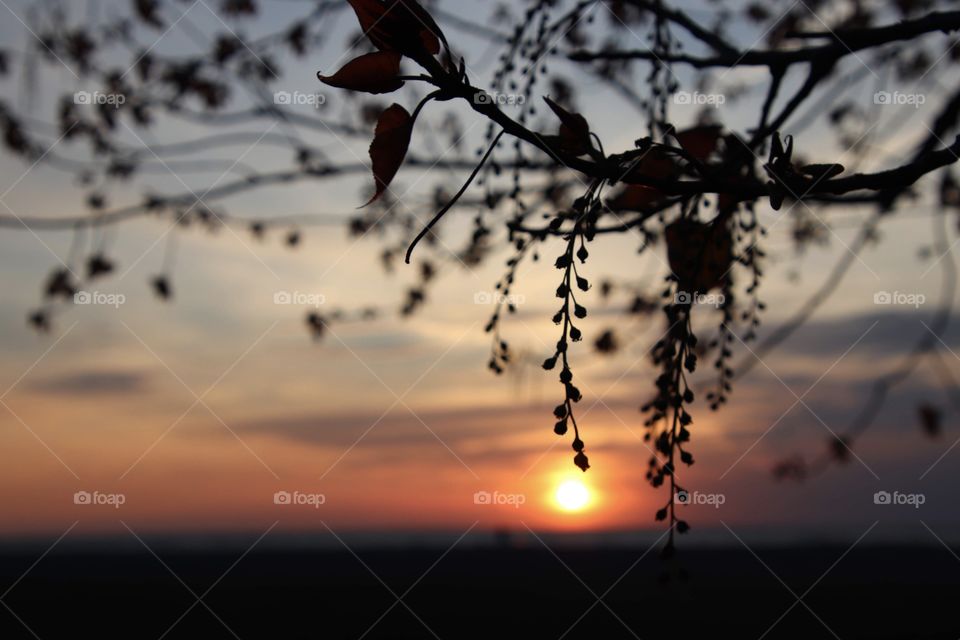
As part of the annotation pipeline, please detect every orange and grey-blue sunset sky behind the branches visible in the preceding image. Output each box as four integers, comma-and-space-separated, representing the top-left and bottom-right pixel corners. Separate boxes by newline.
0, 1, 960, 552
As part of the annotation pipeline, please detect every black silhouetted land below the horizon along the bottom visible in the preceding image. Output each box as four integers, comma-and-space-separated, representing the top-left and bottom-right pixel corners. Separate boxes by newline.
0, 547, 960, 640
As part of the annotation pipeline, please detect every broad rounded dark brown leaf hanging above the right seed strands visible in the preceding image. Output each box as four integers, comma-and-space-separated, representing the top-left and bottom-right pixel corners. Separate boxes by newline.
665, 219, 733, 294
